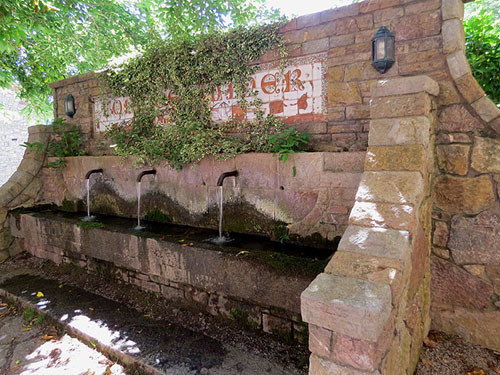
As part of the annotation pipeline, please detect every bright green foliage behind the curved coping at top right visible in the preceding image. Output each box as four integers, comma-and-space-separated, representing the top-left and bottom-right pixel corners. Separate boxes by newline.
464, 9, 500, 103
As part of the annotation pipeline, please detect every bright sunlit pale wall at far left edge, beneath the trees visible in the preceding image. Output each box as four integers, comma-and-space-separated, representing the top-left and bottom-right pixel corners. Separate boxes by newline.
0, 89, 33, 186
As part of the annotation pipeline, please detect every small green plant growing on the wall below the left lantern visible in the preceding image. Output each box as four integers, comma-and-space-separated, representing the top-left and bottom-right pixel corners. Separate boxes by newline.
48, 118, 85, 169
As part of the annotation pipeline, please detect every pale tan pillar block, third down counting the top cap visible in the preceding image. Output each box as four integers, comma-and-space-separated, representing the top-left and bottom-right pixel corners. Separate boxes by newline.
368, 116, 430, 147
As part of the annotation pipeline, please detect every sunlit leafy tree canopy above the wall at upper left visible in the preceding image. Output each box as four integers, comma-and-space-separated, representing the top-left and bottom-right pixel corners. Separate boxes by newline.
0, 0, 280, 118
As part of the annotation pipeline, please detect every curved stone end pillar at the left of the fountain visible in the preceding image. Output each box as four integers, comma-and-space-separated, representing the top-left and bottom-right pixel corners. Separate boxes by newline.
0, 125, 52, 263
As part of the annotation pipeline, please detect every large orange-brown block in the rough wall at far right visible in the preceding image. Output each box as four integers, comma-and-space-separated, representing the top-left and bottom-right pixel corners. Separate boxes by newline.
434, 175, 495, 214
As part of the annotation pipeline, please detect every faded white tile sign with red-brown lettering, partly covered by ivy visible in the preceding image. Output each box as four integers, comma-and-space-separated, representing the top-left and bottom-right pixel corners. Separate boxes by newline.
94, 54, 326, 132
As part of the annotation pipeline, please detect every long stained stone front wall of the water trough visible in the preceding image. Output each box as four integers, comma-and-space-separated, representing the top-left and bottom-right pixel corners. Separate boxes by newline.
9, 212, 314, 342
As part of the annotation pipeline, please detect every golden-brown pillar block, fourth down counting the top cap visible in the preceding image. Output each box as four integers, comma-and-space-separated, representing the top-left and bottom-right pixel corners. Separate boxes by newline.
365, 145, 426, 171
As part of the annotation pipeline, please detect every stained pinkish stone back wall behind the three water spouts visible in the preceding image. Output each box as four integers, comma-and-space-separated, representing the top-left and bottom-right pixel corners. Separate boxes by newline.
39, 152, 365, 246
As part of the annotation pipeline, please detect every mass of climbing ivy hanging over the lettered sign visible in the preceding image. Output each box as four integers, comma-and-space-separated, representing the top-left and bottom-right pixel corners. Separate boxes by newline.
103, 23, 310, 167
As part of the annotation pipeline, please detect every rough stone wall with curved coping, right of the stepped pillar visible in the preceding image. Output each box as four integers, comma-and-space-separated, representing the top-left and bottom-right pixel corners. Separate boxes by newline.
431, 0, 500, 350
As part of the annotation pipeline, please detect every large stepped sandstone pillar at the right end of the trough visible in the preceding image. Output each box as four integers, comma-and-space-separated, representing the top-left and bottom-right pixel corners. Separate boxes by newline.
301, 76, 439, 375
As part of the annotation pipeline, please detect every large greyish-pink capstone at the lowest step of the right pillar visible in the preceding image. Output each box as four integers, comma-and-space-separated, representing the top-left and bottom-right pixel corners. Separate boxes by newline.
301, 273, 391, 341
